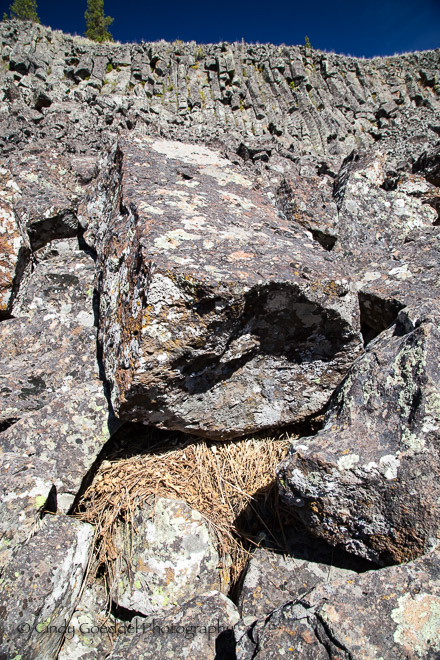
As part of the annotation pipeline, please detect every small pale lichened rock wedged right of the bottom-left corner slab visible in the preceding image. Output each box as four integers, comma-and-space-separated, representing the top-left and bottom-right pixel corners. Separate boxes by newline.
57, 583, 117, 660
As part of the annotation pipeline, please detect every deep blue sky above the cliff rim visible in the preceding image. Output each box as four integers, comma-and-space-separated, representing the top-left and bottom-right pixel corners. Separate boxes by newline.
0, 0, 440, 57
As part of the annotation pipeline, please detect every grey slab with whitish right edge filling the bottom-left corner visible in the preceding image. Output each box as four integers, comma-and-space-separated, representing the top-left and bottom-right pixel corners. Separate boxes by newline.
0, 516, 93, 660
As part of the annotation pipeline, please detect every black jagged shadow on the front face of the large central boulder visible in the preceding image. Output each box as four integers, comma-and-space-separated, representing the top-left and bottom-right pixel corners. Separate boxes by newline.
172, 282, 356, 394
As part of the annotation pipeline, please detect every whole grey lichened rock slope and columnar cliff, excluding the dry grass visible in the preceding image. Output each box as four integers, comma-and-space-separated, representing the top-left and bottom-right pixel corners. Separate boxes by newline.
0, 22, 440, 660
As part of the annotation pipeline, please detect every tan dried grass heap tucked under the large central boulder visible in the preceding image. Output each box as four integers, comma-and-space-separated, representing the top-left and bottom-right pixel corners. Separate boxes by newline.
77, 436, 290, 593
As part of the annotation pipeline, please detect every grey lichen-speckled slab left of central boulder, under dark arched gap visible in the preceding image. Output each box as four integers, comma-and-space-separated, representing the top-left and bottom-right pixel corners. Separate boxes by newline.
0, 245, 98, 421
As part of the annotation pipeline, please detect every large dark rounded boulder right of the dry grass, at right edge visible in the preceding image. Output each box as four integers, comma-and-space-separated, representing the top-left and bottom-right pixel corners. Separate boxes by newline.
278, 306, 440, 564
